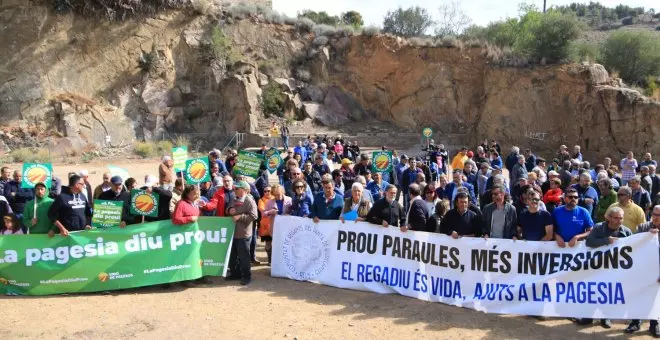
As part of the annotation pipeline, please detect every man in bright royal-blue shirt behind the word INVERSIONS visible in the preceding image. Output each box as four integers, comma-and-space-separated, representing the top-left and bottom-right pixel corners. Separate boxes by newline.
553, 188, 594, 248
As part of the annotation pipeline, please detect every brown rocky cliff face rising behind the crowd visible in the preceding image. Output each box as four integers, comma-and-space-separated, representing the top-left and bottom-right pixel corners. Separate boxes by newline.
0, 1, 660, 157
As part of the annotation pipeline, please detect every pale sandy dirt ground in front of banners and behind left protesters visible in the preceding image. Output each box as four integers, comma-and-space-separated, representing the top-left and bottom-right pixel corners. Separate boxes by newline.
0, 161, 650, 339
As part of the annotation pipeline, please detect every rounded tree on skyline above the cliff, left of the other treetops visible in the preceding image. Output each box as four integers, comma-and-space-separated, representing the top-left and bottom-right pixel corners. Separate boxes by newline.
383, 6, 434, 38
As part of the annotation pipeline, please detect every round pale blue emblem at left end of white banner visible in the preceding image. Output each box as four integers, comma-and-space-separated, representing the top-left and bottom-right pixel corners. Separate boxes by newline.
282, 225, 330, 280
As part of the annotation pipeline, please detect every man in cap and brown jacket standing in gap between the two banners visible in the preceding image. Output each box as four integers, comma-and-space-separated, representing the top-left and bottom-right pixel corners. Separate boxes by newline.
227, 181, 257, 285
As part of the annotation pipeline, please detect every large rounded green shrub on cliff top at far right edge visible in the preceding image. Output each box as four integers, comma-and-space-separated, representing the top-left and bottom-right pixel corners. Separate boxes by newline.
601, 31, 660, 84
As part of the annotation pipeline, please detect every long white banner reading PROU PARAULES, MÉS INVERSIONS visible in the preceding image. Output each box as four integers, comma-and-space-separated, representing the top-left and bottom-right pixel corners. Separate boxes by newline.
271, 216, 660, 319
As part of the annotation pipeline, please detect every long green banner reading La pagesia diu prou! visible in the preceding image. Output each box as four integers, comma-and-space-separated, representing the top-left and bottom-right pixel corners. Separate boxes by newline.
0, 217, 234, 295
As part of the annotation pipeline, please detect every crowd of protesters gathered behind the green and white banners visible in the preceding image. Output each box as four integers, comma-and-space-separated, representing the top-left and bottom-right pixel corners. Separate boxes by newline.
0, 132, 660, 337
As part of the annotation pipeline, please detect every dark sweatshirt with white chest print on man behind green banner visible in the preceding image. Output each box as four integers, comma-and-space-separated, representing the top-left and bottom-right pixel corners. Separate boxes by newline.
48, 191, 92, 231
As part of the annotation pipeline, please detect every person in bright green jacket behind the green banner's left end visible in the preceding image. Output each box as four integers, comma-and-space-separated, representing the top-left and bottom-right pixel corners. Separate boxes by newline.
22, 182, 57, 236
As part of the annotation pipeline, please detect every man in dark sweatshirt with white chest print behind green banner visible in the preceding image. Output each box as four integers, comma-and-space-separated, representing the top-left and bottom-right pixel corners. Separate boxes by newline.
48, 175, 92, 236
